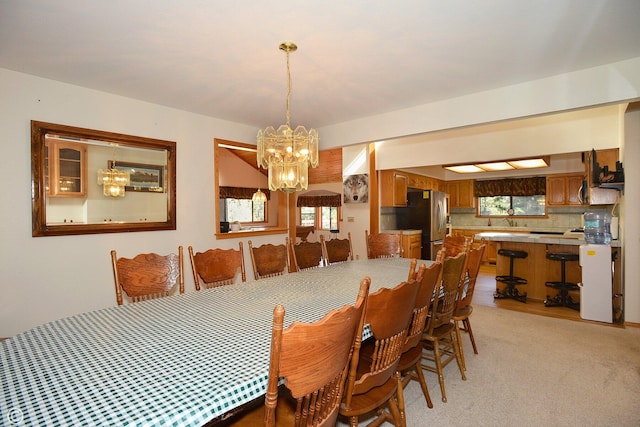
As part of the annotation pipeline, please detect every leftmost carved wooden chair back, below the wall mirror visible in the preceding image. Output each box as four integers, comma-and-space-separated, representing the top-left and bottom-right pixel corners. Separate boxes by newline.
111, 246, 184, 305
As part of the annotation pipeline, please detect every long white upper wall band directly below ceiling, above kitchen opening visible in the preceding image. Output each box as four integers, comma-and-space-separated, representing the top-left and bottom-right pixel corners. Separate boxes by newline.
318, 57, 640, 149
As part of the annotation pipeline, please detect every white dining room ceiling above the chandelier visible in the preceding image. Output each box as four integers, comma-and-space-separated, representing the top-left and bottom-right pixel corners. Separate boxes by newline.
0, 0, 640, 135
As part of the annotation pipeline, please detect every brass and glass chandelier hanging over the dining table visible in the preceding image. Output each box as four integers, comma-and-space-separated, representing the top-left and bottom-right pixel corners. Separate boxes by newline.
257, 42, 318, 193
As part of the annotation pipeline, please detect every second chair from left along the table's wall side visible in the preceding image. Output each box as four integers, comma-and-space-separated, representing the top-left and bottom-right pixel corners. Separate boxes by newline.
189, 242, 247, 291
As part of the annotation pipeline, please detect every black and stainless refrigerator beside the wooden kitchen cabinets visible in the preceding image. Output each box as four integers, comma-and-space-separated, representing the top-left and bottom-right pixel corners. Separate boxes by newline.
396, 189, 447, 259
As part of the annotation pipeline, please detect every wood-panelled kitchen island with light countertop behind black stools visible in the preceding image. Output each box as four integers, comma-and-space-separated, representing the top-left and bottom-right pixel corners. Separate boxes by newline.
475, 232, 622, 321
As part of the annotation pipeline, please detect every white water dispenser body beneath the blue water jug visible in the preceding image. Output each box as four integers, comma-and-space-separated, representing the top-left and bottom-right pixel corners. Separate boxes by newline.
580, 245, 613, 323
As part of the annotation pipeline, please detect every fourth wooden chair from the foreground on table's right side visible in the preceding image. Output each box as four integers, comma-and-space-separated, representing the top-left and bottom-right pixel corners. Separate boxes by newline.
422, 250, 467, 402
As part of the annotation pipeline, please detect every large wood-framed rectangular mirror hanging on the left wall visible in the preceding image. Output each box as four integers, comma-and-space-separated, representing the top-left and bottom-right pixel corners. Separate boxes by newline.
31, 121, 176, 237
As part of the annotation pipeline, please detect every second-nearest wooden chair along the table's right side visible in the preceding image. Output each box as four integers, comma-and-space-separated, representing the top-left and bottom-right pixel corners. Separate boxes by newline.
340, 280, 419, 426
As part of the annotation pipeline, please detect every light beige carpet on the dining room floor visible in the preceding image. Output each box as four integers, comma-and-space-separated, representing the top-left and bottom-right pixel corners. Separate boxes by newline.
339, 305, 640, 427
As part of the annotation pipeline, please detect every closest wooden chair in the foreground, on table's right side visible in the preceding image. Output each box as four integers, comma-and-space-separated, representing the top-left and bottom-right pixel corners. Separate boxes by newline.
225, 277, 371, 427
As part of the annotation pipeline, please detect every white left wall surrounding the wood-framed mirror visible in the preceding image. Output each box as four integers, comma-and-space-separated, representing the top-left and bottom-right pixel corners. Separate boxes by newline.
0, 69, 256, 337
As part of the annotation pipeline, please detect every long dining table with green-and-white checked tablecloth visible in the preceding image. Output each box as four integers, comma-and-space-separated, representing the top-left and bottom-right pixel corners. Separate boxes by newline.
0, 258, 431, 427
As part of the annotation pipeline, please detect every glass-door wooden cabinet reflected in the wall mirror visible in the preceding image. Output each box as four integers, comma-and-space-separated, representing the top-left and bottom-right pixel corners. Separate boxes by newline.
45, 139, 87, 197
